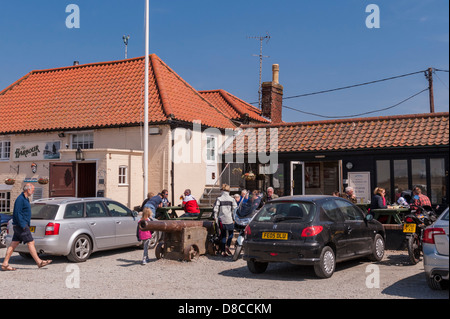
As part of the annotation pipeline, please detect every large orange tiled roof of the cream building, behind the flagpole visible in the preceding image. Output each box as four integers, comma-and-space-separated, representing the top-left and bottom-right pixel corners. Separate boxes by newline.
0, 54, 236, 134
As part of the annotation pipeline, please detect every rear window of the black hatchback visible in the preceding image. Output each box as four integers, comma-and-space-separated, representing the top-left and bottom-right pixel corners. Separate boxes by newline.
254, 201, 316, 223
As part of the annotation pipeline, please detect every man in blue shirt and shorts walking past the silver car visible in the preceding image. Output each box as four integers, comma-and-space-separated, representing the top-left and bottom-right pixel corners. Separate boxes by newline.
2, 184, 52, 271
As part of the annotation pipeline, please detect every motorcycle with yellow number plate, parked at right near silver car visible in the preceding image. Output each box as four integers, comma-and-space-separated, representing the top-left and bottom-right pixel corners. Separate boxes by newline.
403, 206, 436, 265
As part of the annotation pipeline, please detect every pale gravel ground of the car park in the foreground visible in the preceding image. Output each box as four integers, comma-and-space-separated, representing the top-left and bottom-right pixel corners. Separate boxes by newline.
0, 248, 449, 299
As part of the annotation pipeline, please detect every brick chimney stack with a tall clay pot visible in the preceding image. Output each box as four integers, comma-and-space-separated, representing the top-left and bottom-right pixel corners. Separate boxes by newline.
261, 64, 283, 124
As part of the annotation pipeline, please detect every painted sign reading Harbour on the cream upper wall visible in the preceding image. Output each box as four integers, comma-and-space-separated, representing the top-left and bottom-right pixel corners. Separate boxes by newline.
12, 141, 61, 161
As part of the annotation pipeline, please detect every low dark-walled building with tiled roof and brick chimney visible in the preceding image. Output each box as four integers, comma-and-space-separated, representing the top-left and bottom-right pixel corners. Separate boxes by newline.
224, 66, 449, 211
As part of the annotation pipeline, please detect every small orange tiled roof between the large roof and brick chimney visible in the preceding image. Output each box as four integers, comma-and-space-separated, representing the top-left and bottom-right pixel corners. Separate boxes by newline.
199, 90, 270, 123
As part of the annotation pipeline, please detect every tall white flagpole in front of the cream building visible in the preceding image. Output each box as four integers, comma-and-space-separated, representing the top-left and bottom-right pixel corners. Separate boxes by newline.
144, 0, 150, 198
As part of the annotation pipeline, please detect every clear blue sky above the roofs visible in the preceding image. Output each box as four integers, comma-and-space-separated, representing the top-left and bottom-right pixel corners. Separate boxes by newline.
0, 0, 449, 122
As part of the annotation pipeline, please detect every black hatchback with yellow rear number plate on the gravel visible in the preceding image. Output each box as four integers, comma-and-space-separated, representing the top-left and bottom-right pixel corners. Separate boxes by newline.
244, 195, 385, 278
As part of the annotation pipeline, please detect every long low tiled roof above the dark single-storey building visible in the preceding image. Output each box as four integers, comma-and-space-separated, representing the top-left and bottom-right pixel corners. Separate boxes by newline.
227, 112, 449, 153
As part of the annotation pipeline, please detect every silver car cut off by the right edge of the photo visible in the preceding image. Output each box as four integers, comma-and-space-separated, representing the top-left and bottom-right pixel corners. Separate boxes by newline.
423, 208, 449, 290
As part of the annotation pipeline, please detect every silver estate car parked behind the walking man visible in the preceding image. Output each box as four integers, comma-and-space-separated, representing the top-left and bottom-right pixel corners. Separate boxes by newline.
6, 198, 139, 262
